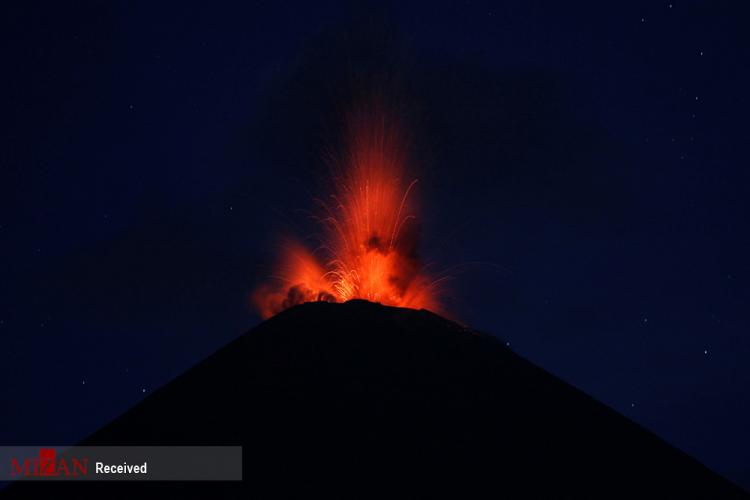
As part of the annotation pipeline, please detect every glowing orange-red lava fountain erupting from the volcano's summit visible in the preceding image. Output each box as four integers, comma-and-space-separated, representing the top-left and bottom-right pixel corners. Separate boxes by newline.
253, 104, 439, 318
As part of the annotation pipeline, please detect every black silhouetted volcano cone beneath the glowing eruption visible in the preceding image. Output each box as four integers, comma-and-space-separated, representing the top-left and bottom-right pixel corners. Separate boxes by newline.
5, 301, 745, 499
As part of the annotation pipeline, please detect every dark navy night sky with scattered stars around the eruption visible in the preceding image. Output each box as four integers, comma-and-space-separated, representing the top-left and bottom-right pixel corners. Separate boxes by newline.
0, 0, 750, 488
